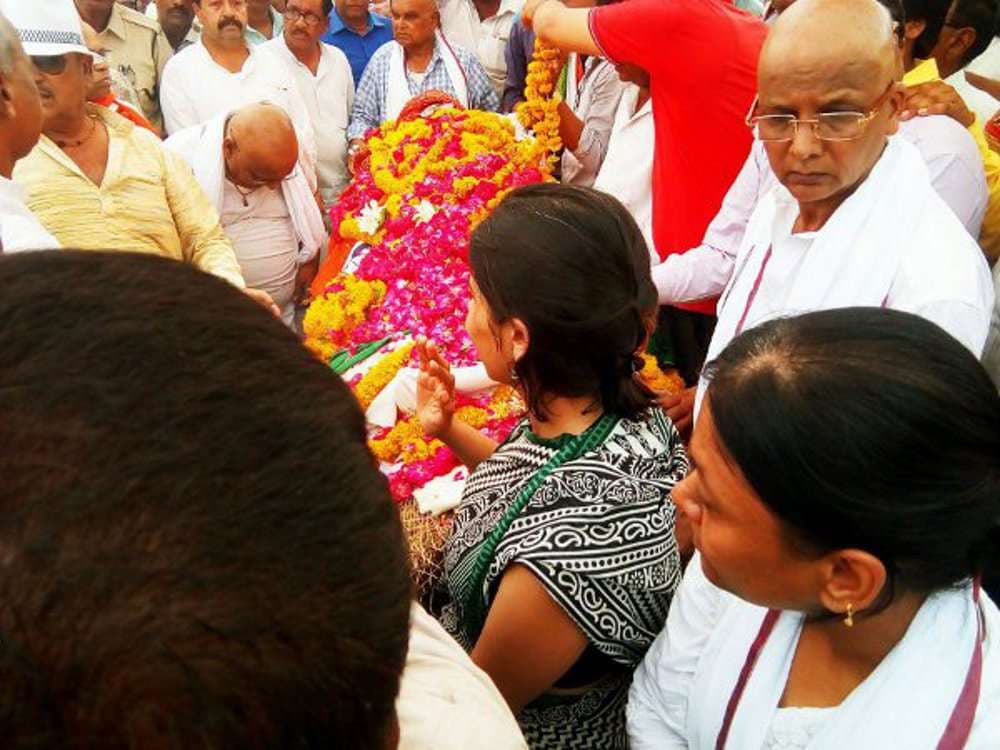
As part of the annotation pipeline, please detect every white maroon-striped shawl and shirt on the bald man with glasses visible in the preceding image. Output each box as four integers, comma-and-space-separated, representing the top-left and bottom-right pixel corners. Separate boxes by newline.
698, 136, 993, 414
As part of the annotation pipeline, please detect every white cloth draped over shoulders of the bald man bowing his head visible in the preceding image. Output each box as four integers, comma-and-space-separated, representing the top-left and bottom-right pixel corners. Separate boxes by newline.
164, 115, 326, 264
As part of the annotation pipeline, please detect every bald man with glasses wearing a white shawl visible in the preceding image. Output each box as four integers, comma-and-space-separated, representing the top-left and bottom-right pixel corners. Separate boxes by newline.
680, 0, 993, 418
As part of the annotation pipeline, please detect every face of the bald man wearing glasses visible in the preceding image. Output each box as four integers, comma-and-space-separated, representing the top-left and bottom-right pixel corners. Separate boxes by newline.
755, 50, 902, 210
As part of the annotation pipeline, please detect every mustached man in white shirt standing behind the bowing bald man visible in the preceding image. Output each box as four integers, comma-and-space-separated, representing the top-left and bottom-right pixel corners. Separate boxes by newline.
160, 0, 316, 189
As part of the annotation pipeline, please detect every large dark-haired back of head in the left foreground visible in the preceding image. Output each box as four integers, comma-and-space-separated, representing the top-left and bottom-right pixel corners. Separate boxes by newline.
0, 251, 410, 750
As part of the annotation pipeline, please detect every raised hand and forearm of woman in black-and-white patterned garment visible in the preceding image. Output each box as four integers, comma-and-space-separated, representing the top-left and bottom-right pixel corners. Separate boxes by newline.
415, 336, 497, 469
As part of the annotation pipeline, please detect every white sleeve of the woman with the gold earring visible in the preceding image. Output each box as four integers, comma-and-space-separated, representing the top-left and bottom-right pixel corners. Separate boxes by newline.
627, 553, 727, 750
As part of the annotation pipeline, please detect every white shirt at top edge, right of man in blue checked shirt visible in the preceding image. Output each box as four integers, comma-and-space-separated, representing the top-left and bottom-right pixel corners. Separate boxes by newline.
438, 0, 524, 96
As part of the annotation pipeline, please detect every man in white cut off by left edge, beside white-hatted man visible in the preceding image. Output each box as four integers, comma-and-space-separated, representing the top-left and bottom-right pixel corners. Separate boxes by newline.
0, 11, 59, 253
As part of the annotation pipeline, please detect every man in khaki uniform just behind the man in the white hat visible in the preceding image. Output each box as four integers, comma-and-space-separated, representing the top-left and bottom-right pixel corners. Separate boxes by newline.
74, 0, 172, 130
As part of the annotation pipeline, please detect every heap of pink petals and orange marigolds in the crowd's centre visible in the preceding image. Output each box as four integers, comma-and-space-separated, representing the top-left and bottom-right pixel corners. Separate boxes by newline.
305, 100, 552, 501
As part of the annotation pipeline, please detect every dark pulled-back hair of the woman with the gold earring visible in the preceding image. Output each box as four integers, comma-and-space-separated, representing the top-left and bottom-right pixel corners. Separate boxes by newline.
708, 308, 1000, 599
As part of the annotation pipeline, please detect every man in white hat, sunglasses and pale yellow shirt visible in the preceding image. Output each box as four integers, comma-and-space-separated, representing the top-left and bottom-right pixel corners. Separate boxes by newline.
7, 0, 282, 308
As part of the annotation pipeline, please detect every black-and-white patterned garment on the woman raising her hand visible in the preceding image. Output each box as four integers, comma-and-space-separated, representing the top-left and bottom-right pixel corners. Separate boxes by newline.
442, 409, 688, 748
